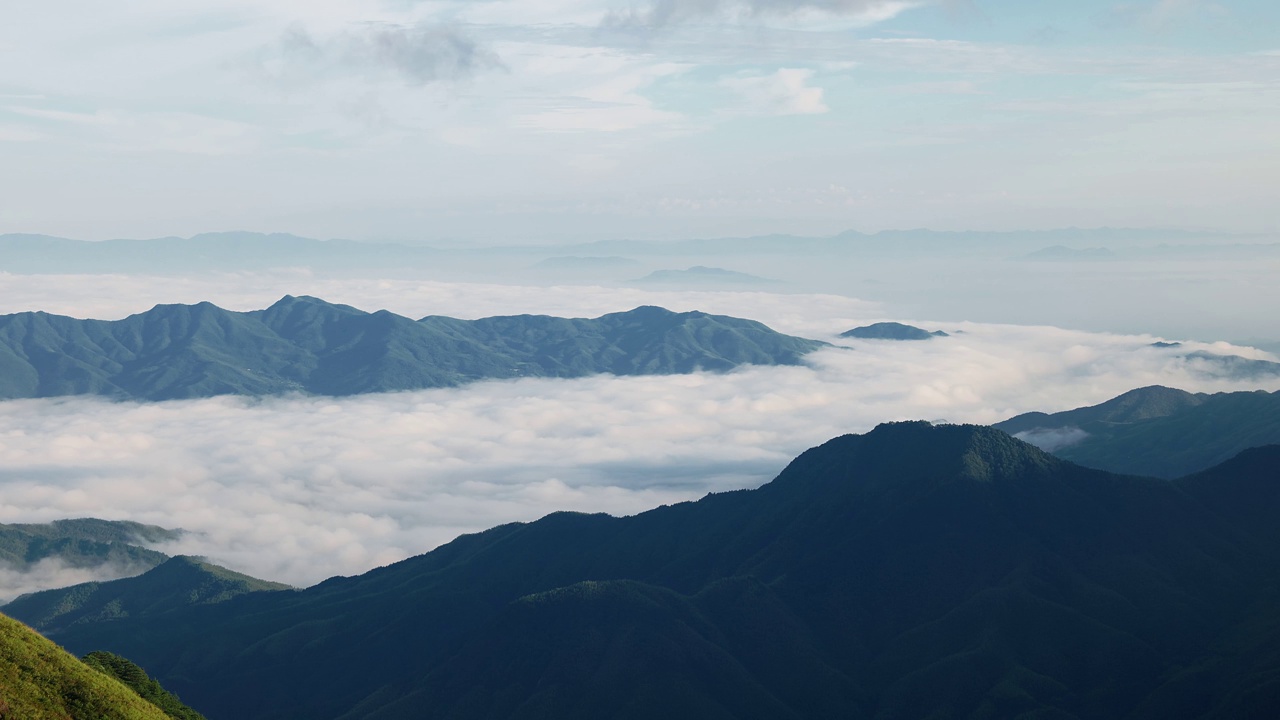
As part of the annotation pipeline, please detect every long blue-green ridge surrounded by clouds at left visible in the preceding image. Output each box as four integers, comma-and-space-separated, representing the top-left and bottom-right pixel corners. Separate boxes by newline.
0, 296, 824, 400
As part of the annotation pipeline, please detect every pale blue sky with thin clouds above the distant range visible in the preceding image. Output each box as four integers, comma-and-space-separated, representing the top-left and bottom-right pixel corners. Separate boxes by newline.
0, 0, 1280, 245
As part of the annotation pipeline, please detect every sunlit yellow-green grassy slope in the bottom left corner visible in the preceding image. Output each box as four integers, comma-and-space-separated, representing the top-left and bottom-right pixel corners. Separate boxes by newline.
0, 615, 169, 720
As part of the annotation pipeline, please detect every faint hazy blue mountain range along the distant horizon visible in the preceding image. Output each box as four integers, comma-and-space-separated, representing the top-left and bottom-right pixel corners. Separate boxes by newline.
0, 228, 1239, 273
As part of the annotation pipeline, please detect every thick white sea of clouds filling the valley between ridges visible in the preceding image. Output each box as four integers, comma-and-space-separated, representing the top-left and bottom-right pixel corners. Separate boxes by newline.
0, 273, 1280, 597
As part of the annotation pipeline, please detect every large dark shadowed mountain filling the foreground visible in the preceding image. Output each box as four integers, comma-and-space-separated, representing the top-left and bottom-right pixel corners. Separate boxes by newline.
27, 423, 1280, 720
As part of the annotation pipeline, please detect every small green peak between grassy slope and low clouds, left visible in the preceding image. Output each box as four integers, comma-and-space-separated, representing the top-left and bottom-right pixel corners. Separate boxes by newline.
4, 556, 289, 633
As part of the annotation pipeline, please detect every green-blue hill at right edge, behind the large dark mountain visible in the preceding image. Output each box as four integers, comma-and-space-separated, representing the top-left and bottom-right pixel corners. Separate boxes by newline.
995, 386, 1280, 478
